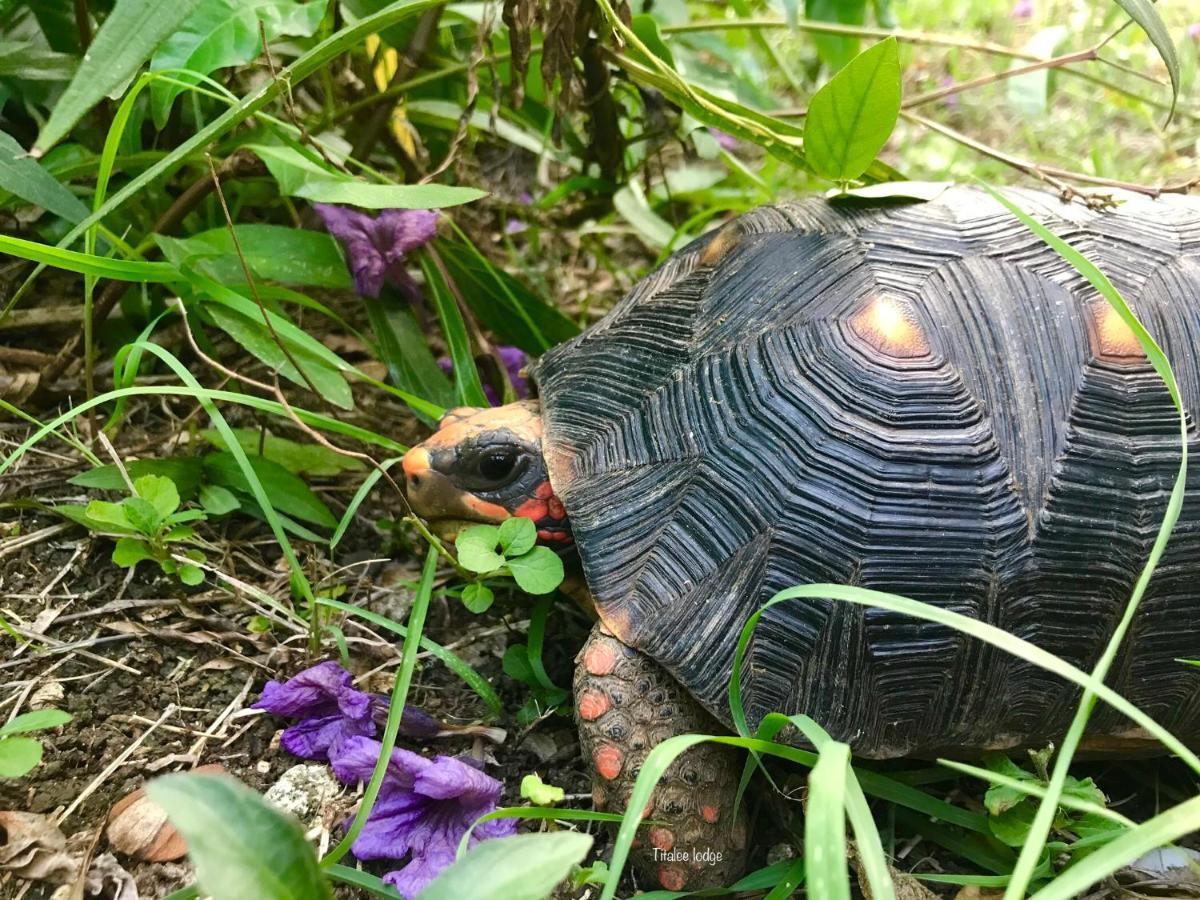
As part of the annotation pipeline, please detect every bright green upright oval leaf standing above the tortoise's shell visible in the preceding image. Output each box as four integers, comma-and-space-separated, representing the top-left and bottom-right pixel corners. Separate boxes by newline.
804, 37, 900, 181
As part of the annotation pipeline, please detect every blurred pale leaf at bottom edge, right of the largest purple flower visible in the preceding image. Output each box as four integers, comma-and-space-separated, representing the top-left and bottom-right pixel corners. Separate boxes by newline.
418, 832, 592, 900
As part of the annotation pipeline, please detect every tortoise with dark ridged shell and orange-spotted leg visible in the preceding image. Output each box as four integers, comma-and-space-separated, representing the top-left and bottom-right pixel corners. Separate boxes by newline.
403, 186, 1200, 890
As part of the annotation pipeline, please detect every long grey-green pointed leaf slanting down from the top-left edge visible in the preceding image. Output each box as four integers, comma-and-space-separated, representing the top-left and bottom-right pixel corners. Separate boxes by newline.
37, 0, 200, 152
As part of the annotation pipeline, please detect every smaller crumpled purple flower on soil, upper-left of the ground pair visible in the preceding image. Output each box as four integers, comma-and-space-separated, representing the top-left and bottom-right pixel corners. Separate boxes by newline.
254, 662, 388, 760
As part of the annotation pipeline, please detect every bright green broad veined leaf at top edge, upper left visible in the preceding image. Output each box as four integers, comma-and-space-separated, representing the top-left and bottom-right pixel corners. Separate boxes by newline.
150, 0, 326, 130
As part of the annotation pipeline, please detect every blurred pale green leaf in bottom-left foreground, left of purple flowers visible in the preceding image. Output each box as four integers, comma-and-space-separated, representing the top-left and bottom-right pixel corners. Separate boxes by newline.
146, 775, 330, 900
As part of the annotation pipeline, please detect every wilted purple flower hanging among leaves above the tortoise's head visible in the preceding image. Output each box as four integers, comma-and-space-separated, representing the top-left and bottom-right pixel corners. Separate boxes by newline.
312, 203, 438, 298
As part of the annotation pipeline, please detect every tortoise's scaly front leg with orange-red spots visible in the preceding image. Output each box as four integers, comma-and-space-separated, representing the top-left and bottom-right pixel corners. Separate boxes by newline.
575, 623, 746, 890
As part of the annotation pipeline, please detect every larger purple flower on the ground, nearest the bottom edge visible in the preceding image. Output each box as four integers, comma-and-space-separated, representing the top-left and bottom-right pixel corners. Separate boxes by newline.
331, 737, 516, 900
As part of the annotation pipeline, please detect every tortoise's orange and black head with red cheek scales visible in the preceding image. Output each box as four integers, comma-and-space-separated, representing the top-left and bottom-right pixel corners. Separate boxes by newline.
403, 400, 571, 546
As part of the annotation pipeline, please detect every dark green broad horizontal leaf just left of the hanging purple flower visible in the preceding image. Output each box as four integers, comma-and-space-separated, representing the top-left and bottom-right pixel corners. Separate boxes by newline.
154, 224, 353, 290
